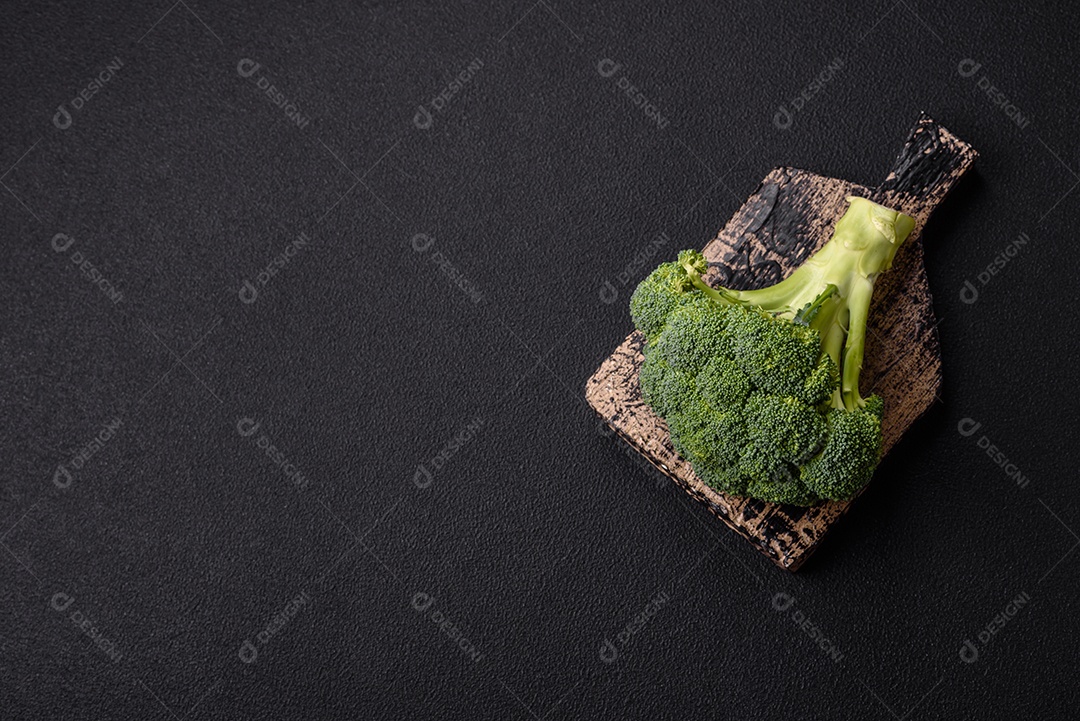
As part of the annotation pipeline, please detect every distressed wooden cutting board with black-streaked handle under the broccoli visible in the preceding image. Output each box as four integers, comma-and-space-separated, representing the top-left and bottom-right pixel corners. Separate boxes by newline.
585, 113, 976, 571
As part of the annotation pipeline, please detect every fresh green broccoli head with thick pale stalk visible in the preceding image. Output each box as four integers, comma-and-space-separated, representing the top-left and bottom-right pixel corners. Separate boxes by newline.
630, 196, 915, 506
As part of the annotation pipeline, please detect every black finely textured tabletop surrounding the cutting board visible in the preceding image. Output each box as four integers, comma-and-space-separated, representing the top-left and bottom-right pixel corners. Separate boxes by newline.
0, 0, 1080, 719
